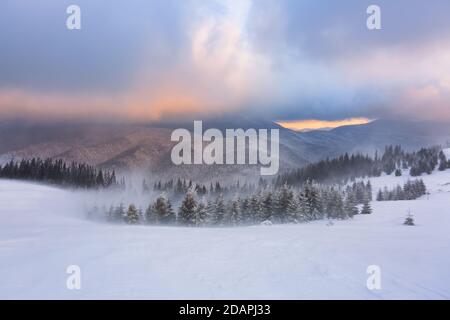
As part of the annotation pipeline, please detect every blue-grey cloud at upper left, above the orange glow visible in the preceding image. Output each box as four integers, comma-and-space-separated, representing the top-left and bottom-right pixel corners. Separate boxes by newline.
0, 0, 190, 91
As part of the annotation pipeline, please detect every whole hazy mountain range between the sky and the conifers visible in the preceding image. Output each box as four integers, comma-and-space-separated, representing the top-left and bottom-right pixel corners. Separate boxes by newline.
0, 117, 450, 178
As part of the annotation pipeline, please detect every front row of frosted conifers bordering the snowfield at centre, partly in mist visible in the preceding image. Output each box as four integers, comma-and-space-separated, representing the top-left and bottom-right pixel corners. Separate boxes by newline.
89, 181, 372, 227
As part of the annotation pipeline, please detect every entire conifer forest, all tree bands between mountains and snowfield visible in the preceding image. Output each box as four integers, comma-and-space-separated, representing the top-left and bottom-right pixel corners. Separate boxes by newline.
0, 146, 444, 226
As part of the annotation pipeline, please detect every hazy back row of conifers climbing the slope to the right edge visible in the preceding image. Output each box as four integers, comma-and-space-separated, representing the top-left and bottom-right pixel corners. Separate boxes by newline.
147, 145, 450, 198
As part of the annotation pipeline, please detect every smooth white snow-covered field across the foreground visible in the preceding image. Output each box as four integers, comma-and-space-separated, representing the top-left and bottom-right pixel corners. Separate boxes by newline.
0, 170, 450, 299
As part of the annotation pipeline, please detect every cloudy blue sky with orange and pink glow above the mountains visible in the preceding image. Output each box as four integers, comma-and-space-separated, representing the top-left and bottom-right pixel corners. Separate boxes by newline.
0, 0, 450, 129
